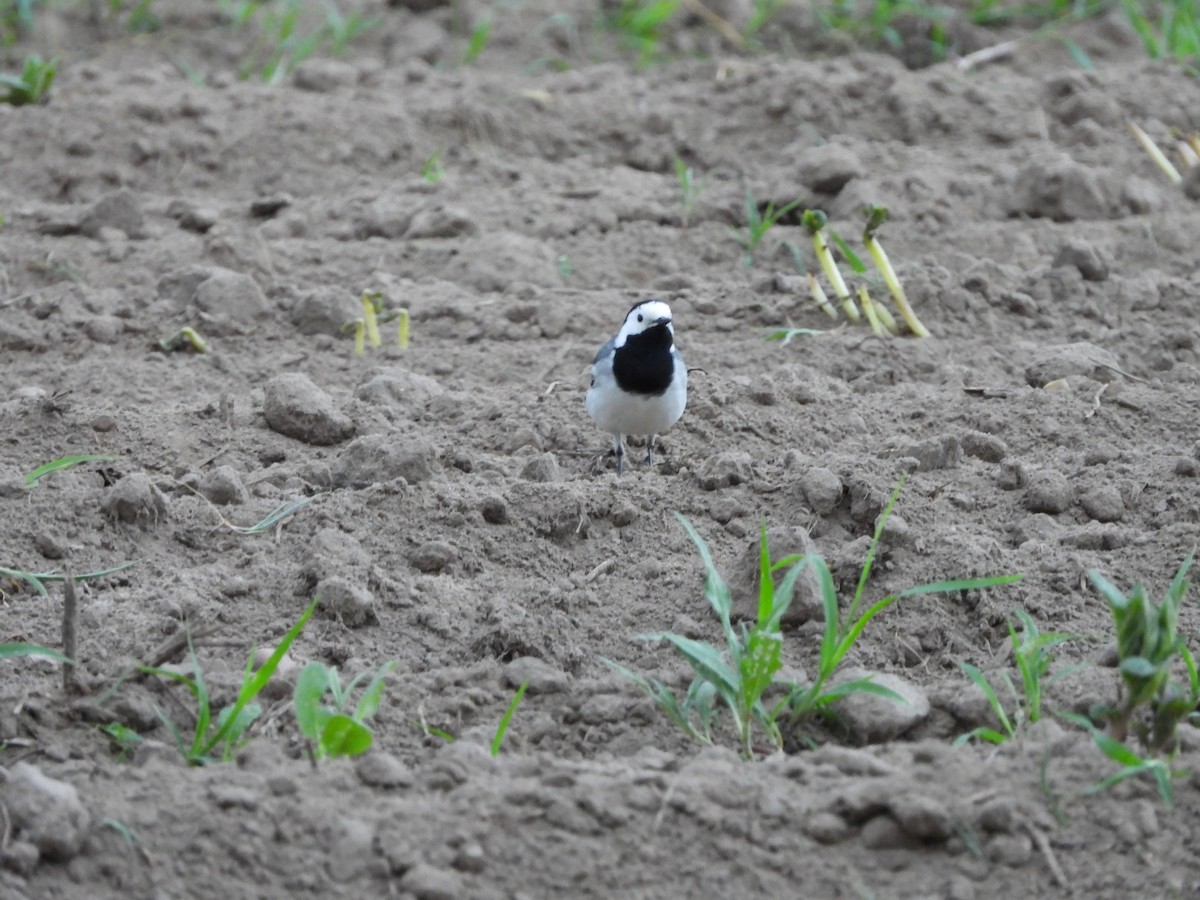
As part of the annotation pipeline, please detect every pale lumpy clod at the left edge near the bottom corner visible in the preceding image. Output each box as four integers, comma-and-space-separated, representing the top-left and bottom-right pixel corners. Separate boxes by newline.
4, 762, 91, 862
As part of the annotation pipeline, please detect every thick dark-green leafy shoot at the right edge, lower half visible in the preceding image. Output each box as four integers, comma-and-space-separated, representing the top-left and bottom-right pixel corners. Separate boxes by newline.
1087, 550, 1200, 754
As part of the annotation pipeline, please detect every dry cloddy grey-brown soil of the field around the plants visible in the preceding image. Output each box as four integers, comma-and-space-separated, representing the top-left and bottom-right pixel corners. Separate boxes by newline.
0, 0, 1200, 900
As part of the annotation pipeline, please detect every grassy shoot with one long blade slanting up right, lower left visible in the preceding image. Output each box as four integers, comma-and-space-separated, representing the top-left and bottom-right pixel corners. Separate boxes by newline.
139, 600, 318, 766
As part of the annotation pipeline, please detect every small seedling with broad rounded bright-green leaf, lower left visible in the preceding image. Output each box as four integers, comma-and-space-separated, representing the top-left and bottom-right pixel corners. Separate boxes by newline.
293, 662, 396, 760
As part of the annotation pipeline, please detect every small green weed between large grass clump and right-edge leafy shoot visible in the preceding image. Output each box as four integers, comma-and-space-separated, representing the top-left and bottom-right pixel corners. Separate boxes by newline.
954, 610, 1081, 746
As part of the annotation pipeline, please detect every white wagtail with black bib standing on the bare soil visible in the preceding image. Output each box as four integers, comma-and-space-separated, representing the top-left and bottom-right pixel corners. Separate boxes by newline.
587, 300, 688, 475
